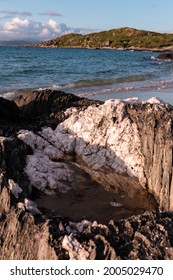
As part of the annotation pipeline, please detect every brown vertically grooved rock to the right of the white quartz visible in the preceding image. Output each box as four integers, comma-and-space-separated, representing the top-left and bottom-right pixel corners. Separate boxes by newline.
128, 99, 173, 211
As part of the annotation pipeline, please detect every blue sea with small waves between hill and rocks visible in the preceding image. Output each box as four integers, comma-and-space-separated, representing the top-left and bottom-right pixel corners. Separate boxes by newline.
0, 46, 173, 104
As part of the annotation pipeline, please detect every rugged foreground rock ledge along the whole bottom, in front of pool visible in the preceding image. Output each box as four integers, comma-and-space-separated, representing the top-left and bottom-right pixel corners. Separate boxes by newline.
0, 210, 173, 260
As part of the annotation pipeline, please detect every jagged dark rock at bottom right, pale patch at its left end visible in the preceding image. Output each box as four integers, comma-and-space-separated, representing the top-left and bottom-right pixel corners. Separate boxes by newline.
62, 212, 173, 260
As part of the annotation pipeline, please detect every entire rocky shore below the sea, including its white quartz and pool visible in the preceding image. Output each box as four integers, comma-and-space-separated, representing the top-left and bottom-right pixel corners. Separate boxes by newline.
0, 90, 173, 260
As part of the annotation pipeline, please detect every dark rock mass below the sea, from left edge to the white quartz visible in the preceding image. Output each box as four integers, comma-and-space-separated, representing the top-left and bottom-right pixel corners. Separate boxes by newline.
0, 90, 103, 134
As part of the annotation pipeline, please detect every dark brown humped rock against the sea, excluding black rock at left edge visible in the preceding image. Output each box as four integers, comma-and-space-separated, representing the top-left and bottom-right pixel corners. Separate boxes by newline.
14, 89, 103, 129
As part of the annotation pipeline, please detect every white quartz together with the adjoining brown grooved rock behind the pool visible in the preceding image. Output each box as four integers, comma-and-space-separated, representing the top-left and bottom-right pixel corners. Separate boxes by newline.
18, 98, 173, 210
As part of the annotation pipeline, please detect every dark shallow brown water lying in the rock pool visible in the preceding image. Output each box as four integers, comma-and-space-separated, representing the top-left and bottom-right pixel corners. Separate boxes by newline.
34, 160, 157, 223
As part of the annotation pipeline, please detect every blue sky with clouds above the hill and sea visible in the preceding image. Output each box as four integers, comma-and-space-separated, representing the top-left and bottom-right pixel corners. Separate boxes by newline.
0, 0, 173, 40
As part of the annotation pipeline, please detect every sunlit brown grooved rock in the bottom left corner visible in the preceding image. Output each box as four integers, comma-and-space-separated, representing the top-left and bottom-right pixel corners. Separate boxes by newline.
0, 210, 58, 260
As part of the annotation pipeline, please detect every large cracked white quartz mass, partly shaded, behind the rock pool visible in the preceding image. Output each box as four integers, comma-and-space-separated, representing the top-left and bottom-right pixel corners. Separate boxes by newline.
18, 98, 163, 193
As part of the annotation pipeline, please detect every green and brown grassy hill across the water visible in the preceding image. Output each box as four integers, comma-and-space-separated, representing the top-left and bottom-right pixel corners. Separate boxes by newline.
34, 27, 173, 51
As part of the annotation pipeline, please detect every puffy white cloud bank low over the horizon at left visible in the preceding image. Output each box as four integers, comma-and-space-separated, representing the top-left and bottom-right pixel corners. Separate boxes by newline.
0, 17, 94, 40
